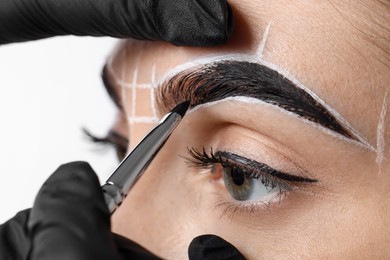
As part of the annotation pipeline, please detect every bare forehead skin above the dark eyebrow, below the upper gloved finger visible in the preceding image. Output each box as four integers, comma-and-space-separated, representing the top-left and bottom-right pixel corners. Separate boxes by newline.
110, 0, 390, 140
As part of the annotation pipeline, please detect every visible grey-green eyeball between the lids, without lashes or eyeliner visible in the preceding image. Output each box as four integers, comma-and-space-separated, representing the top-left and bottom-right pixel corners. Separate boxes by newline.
215, 164, 285, 201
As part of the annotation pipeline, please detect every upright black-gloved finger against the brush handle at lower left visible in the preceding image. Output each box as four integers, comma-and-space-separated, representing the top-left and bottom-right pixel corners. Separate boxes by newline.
28, 162, 119, 259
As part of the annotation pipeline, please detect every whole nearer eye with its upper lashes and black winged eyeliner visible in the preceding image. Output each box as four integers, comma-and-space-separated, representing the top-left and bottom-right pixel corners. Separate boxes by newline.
184, 148, 317, 202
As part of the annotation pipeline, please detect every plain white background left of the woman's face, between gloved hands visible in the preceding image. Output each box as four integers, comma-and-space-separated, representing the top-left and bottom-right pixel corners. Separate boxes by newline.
0, 36, 117, 223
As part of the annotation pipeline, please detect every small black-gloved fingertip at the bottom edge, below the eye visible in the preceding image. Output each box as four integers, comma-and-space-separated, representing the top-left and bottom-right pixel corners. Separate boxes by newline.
188, 235, 245, 260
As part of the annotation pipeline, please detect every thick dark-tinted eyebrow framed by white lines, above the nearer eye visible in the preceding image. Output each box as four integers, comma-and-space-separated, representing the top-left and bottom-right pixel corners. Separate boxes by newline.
156, 60, 361, 142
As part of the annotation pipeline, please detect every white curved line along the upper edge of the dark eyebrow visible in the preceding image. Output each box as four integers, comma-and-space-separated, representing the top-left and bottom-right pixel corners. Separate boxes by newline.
158, 53, 376, 151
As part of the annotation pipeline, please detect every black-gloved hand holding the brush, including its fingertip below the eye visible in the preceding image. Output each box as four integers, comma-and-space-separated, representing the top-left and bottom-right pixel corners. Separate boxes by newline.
0, 162, 243, 260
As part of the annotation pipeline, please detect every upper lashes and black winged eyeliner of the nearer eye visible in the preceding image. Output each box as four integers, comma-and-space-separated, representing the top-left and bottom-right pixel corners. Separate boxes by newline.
185, 147, 317, 186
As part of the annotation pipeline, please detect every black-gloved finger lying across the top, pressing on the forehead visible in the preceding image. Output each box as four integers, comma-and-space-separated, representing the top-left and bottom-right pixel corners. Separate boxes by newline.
0, 0, 233, 46
